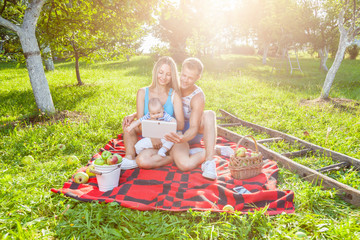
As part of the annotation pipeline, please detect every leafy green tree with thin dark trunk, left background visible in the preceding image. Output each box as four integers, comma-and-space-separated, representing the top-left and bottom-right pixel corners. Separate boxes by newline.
39, 0, 157, 85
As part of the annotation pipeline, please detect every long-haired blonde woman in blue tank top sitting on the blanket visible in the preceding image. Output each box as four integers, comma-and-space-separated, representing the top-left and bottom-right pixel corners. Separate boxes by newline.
121, 57, 184, 170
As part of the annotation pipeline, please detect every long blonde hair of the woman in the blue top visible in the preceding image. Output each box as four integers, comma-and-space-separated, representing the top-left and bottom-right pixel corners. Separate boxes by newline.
150, 57, 181, 95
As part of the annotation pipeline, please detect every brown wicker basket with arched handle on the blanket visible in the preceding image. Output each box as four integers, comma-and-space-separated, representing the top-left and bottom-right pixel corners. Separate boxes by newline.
229, 135, 264, 179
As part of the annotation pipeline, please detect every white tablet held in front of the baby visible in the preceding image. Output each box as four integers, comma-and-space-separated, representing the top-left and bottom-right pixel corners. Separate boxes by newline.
141, 120, 176, 138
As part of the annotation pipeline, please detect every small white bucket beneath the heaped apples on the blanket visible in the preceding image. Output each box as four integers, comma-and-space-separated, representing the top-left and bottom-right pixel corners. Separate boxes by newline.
94, 163, 121, 192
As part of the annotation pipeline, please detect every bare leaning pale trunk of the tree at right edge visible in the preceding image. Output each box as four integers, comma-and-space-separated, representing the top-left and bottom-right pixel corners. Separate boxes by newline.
320, 10, 354, 99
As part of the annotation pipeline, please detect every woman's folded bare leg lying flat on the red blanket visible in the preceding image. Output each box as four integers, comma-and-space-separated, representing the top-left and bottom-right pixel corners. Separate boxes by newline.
136, 148, 172, 169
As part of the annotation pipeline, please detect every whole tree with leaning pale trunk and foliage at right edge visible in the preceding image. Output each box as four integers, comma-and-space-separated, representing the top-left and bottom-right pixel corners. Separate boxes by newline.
320, 0, 360, 99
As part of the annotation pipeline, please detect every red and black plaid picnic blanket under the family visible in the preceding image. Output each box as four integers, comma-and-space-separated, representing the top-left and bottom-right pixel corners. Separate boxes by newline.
51, 135, 295, 215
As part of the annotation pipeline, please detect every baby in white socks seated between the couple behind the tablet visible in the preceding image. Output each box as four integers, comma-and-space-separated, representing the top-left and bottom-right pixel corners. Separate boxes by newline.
126, 98, 176, 157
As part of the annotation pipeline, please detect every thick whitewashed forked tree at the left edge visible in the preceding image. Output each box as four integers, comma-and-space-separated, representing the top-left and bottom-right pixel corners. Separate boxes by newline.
0, 0, 55, 113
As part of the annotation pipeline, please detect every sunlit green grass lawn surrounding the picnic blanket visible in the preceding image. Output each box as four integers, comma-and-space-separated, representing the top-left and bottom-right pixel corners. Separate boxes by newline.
0, 55, 360, 239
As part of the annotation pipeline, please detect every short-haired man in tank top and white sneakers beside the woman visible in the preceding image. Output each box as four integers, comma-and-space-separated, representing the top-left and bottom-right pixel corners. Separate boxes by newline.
165, 58, 233, 180
